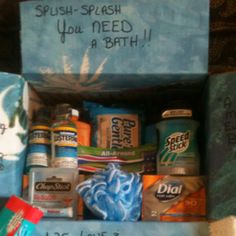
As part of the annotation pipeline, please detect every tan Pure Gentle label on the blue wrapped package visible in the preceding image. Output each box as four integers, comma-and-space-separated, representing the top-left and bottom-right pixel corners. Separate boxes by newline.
97, 114, 140, 148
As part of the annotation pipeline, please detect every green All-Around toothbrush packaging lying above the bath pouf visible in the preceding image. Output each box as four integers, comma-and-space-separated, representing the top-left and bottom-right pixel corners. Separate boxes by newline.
78, 145, 156, 173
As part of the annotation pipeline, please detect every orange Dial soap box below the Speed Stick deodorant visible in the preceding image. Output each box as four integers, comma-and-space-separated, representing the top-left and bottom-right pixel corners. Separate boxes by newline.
142, 175, 206, 222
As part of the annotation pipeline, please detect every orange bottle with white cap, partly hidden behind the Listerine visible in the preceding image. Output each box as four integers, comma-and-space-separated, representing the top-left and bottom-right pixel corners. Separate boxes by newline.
71, 109, 91, 146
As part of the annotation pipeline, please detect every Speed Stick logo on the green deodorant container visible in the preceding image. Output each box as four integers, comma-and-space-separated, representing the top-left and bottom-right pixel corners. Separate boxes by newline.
165, 131, 190, 153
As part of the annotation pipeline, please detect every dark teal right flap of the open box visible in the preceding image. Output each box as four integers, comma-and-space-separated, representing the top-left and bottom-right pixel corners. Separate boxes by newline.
206, 73, 236, 220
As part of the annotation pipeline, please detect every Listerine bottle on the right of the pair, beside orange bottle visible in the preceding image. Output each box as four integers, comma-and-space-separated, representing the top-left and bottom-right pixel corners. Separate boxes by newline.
52, 104, 78, 168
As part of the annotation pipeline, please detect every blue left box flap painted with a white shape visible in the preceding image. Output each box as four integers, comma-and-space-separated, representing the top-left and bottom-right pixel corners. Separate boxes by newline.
0, 73, 28, 197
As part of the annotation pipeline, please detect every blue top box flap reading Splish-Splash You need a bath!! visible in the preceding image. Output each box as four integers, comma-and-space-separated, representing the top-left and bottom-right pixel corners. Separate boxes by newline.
21, 0, 209, 93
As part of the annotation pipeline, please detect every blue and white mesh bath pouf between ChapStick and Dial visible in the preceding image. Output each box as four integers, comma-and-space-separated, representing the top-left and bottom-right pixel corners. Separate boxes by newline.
77, 163, 142, 221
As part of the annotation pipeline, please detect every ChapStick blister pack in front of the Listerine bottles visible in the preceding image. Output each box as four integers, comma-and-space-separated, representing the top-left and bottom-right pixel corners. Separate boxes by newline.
29, 168, 78, 218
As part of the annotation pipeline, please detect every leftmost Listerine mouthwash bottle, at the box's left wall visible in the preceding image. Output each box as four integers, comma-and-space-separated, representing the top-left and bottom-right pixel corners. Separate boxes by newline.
26, 107, 51, 172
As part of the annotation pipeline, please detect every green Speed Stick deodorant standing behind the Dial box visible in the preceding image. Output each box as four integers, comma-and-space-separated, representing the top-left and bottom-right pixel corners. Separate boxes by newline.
156, 103, 200, 175
